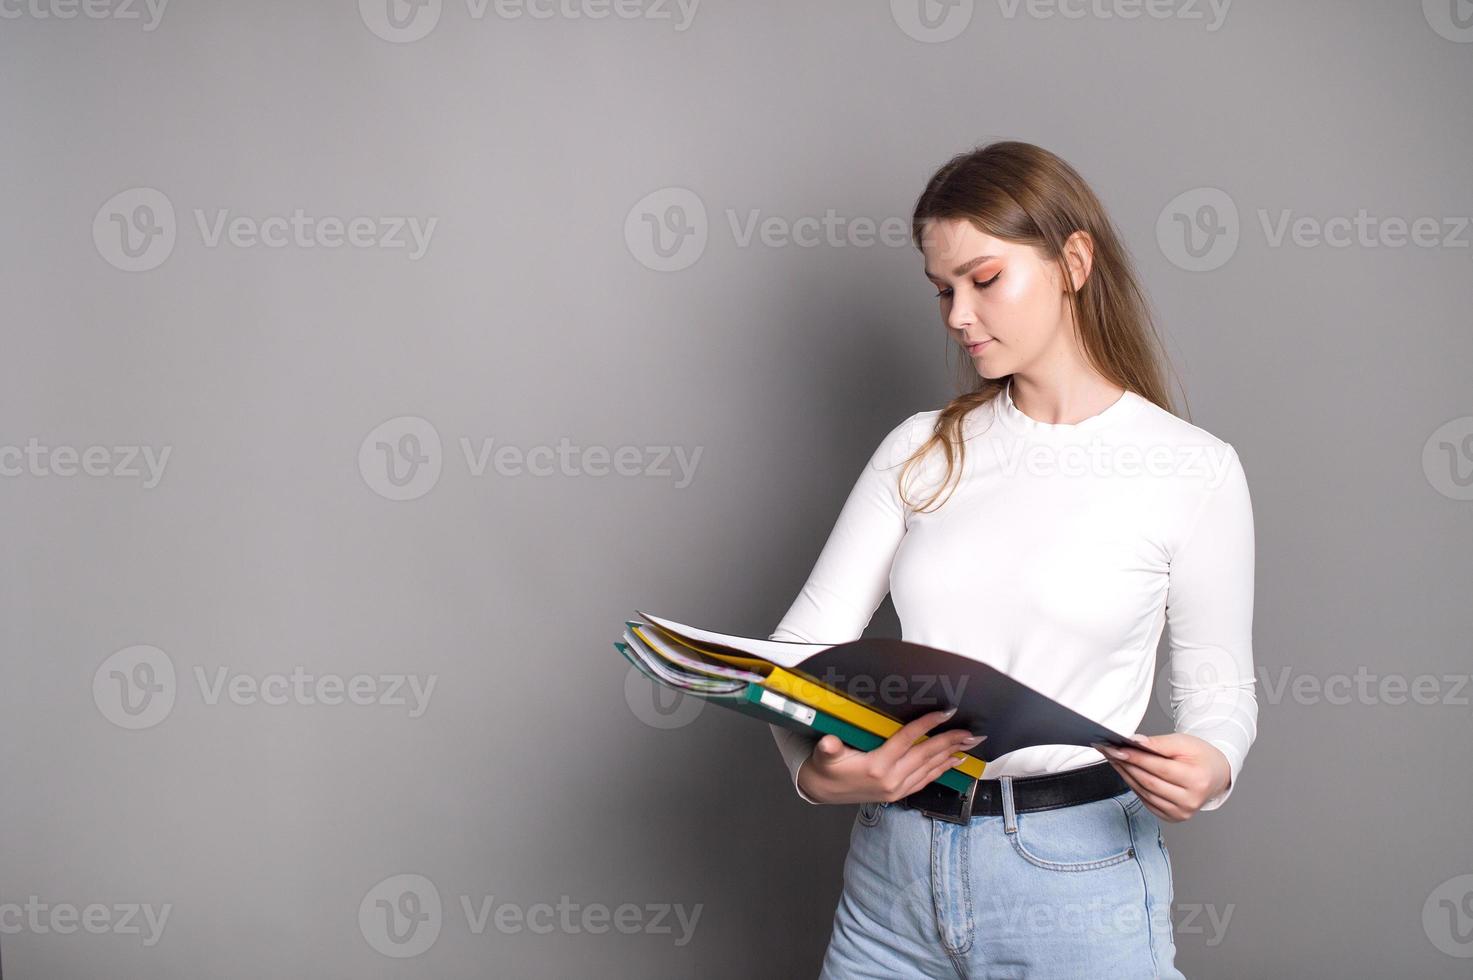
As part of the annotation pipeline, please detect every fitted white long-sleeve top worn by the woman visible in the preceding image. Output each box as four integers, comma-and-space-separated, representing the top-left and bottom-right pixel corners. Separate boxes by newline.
770, 386, 1258, 811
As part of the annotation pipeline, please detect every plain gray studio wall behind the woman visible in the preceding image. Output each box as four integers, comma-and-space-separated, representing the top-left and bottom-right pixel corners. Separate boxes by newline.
0, 0, 1473, 980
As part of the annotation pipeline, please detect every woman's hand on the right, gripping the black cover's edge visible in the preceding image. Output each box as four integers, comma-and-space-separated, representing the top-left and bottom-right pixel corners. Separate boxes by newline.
1096, 732, 1233, 824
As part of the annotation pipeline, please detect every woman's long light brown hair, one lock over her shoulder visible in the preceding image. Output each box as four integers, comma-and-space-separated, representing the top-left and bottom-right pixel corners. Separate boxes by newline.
900, 140, 1174, 510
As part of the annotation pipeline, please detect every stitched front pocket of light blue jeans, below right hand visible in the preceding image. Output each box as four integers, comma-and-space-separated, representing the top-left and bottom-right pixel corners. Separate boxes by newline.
1009, 796, 1139, 871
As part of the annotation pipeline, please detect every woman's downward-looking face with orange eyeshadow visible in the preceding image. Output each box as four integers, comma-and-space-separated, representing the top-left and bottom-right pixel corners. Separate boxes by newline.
921, 218, 1074, 377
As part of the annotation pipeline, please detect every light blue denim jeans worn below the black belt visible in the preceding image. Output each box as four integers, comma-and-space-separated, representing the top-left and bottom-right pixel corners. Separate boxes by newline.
820, 777, 1181, 980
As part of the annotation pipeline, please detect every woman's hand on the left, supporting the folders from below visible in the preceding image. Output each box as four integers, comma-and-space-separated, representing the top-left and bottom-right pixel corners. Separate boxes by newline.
798, 707, 987, 803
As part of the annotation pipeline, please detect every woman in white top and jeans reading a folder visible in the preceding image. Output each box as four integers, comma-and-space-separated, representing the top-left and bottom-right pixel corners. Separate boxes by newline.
772, 141, 1258, 980
